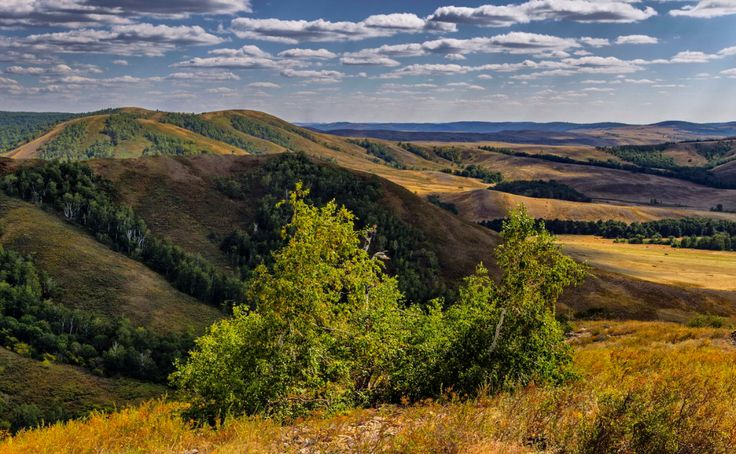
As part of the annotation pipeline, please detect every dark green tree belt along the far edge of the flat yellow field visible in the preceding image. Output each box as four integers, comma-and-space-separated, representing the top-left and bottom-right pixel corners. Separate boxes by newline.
481, 218, 736, 251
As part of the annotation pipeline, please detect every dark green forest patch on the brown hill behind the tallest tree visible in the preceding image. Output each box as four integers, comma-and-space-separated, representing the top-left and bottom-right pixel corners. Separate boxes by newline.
218, 154, 446, 301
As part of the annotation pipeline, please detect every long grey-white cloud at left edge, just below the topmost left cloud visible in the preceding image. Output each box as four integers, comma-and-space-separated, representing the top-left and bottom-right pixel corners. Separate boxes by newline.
0, 23, 224, 56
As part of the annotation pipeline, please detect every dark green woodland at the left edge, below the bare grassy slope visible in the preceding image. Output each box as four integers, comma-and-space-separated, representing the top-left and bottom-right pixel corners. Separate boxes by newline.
0, 248, 193, 382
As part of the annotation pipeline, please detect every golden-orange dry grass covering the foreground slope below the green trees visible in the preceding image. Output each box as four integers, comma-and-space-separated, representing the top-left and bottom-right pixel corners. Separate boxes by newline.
5, 321, 736, 453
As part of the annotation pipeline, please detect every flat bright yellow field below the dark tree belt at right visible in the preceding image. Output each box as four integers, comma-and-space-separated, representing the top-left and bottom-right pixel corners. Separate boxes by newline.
559, 235, 736, 291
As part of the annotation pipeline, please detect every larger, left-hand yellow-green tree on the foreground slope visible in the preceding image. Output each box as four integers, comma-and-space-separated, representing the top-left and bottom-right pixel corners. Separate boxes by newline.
172, 185, 405, 417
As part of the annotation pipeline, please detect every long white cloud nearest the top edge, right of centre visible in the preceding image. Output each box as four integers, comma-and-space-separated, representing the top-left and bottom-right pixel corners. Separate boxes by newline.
430, 0, 657, 27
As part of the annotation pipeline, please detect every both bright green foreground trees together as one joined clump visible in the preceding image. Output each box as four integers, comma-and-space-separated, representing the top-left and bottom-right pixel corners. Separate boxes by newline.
172, 192, 585, 420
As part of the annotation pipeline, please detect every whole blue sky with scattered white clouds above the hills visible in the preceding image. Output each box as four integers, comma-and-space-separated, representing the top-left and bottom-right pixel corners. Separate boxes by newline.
0, 0, 736, 124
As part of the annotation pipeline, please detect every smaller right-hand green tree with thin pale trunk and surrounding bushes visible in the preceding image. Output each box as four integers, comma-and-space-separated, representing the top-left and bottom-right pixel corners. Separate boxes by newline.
394, 207, 586, 399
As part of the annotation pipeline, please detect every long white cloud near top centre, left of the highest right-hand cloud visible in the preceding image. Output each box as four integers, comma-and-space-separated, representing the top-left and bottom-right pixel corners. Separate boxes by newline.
230, 13, 455, 44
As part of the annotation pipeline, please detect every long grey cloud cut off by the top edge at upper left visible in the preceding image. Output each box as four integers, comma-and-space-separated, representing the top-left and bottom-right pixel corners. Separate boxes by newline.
0, 0, 252, 27
